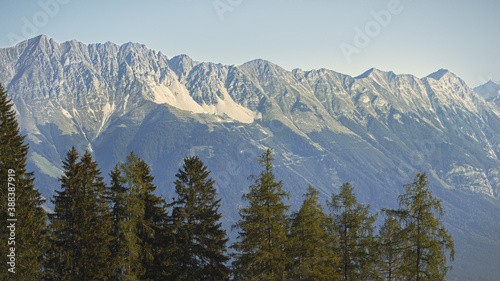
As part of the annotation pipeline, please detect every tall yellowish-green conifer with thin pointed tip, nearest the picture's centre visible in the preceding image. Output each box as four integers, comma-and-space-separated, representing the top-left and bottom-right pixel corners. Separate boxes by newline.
231, 149, 289, 280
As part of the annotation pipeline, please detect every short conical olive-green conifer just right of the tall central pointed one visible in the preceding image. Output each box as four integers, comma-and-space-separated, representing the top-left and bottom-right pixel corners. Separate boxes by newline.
290, 186, 340, 280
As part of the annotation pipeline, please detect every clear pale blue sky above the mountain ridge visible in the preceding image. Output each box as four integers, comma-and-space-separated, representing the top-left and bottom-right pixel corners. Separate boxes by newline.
0, 0, 500, 87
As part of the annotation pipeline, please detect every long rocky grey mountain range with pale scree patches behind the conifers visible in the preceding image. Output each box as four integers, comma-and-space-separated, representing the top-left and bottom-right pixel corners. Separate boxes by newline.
0, 36, 500, 280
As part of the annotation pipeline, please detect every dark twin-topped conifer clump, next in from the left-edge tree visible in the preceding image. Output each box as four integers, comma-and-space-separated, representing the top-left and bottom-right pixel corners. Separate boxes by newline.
46, 147, 112, 280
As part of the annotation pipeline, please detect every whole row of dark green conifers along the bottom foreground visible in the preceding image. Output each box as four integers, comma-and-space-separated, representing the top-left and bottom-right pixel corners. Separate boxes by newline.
0, 82, 454, 280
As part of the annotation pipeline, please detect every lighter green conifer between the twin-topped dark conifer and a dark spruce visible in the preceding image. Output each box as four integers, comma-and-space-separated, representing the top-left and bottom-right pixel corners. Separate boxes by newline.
110, 152, 168, 280
